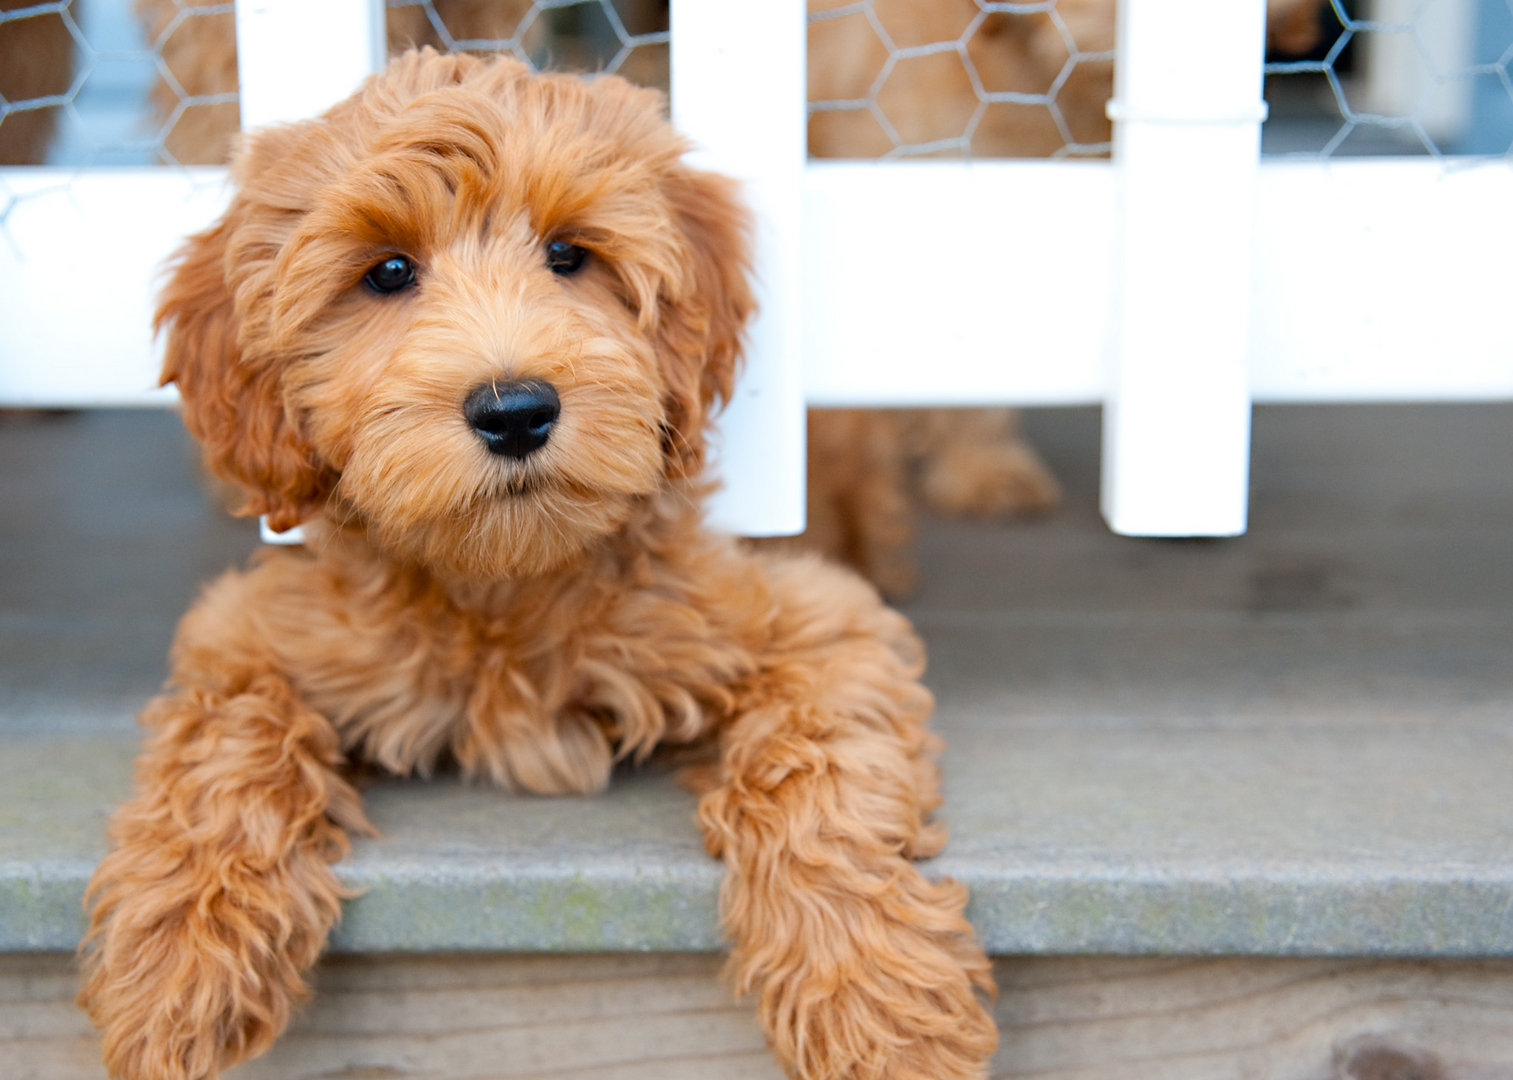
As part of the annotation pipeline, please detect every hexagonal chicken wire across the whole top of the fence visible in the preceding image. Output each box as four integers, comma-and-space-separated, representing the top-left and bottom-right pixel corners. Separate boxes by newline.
0, 0, 1513, 166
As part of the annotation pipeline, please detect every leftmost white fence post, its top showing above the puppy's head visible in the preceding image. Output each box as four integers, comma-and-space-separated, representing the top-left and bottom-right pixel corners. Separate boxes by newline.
236, 0, 386, 130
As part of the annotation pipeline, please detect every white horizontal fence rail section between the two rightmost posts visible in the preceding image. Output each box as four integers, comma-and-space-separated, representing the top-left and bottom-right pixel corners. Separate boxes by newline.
803, 160, 1114, 405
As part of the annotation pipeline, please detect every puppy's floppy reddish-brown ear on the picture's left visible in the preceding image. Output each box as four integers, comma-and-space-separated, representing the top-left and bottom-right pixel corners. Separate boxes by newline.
154, 207, 334, 531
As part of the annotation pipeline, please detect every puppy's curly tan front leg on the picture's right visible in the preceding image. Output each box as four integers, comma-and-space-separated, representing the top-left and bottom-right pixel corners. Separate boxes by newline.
699, 563, 997, 1080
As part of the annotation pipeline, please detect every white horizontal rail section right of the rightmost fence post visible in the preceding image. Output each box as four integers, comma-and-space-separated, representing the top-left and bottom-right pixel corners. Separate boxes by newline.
1250, 157, 1513, 401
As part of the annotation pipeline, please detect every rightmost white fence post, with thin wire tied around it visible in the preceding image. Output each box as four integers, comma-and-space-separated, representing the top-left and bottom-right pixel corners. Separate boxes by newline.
1103, 0, 1266, 535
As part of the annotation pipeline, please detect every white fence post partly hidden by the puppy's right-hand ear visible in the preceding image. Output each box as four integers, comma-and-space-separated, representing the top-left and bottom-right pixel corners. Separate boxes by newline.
672, 0, 806, 535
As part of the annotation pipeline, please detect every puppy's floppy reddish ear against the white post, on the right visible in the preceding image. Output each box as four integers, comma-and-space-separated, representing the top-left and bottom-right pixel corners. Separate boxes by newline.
657, 166, 757, 476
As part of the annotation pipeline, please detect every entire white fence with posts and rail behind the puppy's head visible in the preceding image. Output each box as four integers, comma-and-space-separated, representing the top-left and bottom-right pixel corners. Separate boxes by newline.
0, 0, 1513, 535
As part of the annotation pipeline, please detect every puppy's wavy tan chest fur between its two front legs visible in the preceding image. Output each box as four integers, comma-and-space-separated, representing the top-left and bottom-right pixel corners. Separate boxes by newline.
278, 571, 750, 787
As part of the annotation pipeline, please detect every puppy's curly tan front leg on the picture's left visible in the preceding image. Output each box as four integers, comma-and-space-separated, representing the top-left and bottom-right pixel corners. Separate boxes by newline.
79, 670, 366, 1080
